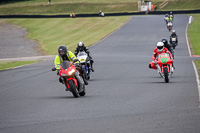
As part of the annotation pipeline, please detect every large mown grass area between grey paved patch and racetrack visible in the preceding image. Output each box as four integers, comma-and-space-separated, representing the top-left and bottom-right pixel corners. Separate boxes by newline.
5, 16, 130, 55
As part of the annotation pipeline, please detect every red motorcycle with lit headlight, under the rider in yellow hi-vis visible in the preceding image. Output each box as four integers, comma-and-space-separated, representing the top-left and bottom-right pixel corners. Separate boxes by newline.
52, 60, 86, 98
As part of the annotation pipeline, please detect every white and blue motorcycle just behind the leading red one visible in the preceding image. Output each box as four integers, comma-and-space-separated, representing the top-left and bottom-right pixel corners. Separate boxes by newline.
77, 51, 91, 80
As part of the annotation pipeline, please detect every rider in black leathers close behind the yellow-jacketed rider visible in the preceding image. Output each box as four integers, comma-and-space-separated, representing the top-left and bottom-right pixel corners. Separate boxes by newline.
74, 42, 94, 72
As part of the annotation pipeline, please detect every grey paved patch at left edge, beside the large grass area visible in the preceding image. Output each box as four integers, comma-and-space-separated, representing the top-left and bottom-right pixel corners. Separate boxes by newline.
0, 20, 41, 59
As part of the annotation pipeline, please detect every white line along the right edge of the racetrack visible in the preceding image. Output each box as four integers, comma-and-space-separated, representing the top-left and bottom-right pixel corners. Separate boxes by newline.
185, 16, 200, 107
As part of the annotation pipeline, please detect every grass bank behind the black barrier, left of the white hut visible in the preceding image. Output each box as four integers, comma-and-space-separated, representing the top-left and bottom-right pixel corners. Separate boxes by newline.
0, 3, 137, 15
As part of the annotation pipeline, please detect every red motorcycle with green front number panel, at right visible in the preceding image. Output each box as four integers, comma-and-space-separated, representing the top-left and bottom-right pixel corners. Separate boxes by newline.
156, 53, 174, 83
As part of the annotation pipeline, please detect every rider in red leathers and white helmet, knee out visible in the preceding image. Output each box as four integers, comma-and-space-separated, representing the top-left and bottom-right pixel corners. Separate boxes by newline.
149, 42, 173, 69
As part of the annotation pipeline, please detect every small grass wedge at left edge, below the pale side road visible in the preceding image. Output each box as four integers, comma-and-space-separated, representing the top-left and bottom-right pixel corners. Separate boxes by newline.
0, 61, 39, 70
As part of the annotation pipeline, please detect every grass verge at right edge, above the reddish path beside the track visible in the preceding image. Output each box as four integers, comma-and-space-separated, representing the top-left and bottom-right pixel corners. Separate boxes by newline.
188, 14, 200, 55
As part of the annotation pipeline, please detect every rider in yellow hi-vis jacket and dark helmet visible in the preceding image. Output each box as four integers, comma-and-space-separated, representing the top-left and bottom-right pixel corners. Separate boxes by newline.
54, 45, 88, 85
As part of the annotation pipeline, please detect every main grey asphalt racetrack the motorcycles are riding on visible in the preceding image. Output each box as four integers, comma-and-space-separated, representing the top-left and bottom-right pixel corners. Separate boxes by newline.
0, 15, 200, 133
